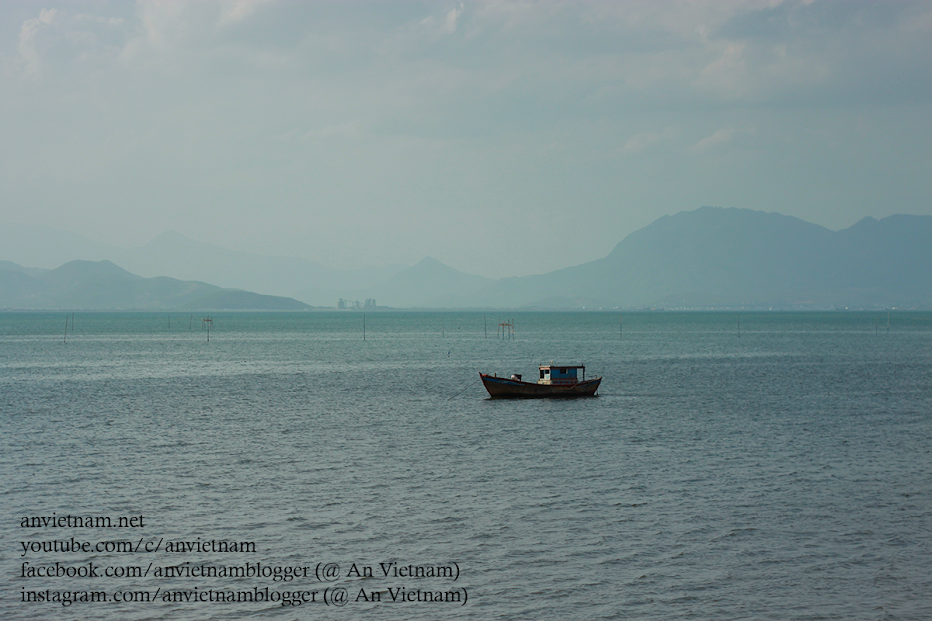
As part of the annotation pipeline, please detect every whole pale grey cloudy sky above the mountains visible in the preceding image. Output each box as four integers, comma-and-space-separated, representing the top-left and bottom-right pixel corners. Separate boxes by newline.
0, 0, 932, 277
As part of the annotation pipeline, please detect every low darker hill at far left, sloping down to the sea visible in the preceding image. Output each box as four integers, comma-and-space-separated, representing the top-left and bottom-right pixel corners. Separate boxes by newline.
0, 261, 309, 310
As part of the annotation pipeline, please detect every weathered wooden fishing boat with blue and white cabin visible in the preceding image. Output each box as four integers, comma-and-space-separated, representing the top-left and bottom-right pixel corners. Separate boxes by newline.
479, 363, 602, 399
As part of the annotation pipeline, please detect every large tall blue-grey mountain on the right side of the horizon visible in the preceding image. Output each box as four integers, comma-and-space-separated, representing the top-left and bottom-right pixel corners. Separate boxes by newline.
474, 207, 932, 308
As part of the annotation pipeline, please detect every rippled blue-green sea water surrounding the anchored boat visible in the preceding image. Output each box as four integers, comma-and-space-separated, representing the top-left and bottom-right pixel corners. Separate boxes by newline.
0, 312, 932, 620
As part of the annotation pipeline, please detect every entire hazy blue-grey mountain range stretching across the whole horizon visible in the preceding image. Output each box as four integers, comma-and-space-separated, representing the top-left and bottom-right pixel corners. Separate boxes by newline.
0, 207, 932, 309
